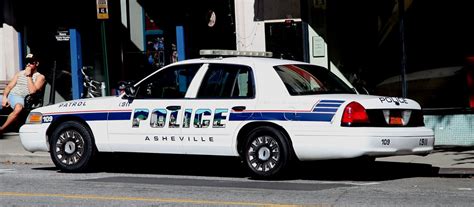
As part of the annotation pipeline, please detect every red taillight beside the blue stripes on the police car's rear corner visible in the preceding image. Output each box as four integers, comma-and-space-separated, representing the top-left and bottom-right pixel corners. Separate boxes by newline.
341, 102, 369, 126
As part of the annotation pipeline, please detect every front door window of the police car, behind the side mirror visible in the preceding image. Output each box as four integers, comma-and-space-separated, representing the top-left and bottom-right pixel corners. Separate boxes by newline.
136, 64, 201, 99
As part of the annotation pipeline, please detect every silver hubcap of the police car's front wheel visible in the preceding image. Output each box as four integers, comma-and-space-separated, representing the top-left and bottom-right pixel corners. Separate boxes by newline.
54, 129, 84, 165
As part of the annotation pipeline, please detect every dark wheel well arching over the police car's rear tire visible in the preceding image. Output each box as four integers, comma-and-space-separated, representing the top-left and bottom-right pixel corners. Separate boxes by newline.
237, 122, 294, 156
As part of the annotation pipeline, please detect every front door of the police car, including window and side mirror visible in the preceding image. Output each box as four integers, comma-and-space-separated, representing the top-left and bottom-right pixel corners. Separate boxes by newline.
108, 64, 202, 153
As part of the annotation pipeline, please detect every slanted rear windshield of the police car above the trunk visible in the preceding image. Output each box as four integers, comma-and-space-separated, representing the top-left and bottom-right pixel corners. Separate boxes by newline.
274, 65, 355, 96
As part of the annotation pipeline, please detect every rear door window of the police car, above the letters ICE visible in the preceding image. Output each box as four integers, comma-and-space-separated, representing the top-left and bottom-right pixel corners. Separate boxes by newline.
197, 64, 254, 98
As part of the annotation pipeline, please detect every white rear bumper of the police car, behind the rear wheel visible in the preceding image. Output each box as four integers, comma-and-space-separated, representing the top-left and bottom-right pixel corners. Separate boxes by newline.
293, 127, 435, 160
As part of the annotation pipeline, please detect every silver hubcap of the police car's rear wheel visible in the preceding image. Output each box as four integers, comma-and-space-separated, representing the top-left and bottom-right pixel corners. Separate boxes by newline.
247, 136, 280, 172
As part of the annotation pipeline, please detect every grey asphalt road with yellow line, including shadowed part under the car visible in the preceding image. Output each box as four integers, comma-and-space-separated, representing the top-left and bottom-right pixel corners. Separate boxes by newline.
0, 155, 474, 206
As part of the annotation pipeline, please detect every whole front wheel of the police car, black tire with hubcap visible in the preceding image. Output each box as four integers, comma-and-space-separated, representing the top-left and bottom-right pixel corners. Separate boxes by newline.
50, 121, 97, 172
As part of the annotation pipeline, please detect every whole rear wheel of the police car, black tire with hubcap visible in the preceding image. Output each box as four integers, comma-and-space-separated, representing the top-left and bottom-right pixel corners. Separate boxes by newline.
242, 126, 291, 178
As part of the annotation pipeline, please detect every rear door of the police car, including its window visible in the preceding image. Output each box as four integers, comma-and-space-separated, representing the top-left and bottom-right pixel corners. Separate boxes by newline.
182, 63, 256, 155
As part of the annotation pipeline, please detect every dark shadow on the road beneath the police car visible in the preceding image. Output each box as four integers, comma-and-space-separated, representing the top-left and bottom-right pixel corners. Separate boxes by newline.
35, 153, 446, 181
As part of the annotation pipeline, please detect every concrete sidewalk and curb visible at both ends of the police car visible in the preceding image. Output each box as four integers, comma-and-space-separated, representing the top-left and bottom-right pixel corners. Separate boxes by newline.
0, 133, 474, 176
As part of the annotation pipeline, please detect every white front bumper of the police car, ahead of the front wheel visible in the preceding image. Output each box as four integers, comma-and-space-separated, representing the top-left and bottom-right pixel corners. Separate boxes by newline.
20, 124, 49, 152
